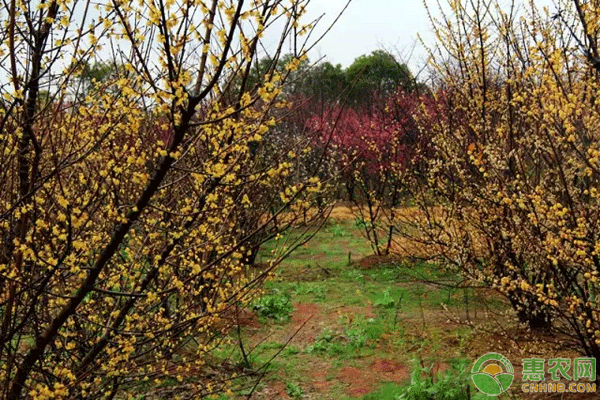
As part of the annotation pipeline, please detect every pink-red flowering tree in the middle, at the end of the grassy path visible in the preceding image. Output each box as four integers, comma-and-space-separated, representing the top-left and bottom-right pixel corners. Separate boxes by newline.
307, 89, 428, 255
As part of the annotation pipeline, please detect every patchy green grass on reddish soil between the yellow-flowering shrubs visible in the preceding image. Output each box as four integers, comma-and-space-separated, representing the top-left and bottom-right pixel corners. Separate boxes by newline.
217, 220, 506, 400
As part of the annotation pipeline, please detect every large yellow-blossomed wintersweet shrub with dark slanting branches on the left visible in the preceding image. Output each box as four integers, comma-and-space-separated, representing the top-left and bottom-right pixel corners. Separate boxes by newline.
0, 0, 328, 399
